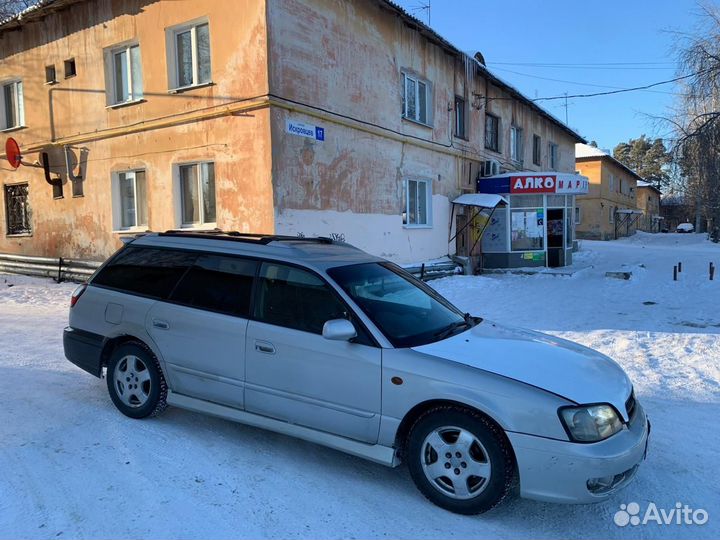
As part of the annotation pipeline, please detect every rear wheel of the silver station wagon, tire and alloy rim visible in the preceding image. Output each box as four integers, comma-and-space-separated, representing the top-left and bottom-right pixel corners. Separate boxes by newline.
106, 341, 167, 418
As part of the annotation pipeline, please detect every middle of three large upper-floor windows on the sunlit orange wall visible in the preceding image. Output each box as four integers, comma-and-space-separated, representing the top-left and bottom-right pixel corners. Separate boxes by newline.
105, 43, 143, 105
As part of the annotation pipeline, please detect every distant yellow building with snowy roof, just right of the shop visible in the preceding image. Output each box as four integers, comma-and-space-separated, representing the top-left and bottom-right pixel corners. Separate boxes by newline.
575, 144, 642, 240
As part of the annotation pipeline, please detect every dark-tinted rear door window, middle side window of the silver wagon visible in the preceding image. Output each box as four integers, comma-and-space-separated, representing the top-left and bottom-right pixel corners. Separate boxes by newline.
170, 255, 258, 317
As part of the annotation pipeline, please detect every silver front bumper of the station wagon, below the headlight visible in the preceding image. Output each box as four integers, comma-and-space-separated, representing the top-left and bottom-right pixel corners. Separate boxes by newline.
507, 403, 650, 504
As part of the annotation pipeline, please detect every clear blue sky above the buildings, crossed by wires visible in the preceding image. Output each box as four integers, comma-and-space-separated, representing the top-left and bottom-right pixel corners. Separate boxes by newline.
396, 0, 700, 148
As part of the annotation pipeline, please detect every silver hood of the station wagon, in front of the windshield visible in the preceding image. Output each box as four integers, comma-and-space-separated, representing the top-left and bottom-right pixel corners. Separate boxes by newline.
413, 321, 632, 416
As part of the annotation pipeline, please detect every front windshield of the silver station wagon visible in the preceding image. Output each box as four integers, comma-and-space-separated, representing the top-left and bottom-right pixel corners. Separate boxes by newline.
328, 263, 478, 348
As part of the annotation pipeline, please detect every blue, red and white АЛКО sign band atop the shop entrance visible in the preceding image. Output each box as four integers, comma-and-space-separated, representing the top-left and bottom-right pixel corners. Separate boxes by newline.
478, 171, 589, 195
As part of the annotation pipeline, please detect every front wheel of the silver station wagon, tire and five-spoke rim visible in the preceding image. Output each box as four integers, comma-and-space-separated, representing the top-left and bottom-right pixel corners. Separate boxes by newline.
405, 406, 516, 514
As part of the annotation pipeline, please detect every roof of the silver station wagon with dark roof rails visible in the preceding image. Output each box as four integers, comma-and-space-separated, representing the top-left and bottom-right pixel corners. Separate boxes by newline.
128, 230, 384, 270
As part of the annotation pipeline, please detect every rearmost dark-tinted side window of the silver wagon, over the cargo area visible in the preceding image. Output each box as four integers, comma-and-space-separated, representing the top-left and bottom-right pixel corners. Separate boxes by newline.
92, 246, 197, 299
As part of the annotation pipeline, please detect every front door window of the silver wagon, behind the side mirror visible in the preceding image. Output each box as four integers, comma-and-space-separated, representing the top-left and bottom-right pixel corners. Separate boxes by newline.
255, 263, 350, 334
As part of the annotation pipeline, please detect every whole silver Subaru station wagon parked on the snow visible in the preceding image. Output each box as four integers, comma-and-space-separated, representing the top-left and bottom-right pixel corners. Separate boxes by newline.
64, 231, 650, 514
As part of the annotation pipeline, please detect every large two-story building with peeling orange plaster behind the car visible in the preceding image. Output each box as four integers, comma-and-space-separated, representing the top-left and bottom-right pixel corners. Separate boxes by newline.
0, 0, 582, 262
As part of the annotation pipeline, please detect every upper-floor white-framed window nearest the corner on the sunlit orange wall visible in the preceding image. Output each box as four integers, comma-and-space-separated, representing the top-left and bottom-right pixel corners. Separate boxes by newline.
167, 22, 212, 88
